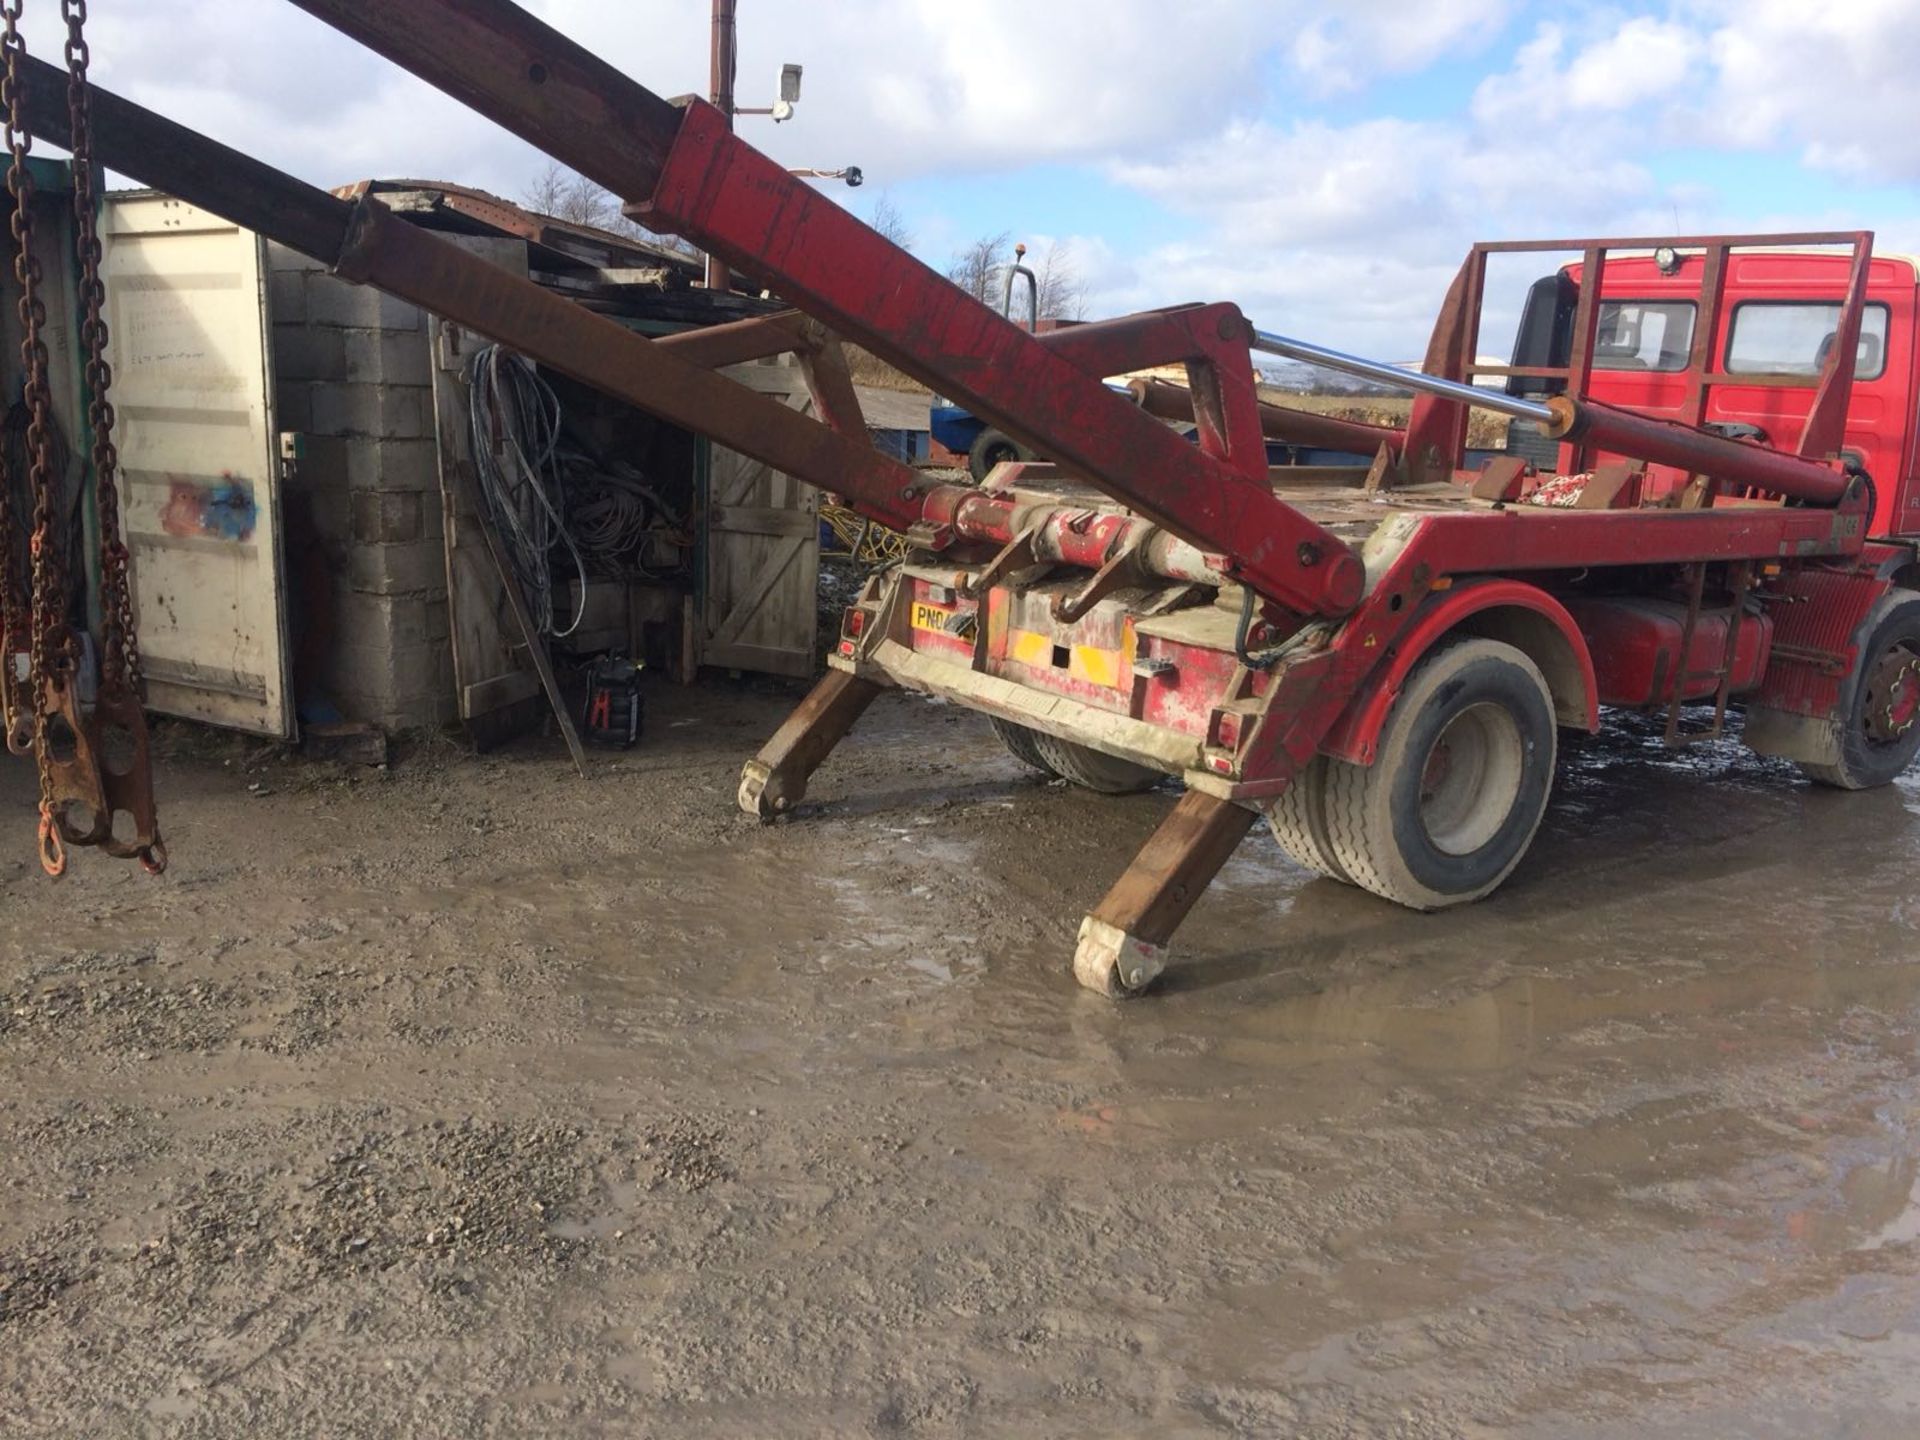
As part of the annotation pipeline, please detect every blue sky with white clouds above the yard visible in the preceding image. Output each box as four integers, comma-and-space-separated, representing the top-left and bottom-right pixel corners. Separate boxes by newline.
82, 0, 1920, 361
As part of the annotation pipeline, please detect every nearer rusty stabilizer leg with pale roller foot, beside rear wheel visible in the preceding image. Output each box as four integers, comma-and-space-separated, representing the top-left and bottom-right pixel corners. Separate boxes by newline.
1073, 789, 1260, 998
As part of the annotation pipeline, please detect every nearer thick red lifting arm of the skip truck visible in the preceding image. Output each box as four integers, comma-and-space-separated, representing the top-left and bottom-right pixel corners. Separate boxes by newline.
280, 0, 1363, 616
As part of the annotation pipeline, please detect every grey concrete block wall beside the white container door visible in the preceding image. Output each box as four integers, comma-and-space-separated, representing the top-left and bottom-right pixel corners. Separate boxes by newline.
269, 246, 455, 730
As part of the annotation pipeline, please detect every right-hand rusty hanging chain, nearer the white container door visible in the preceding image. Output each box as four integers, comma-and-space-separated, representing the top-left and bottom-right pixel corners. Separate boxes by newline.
60, 0, 140, 691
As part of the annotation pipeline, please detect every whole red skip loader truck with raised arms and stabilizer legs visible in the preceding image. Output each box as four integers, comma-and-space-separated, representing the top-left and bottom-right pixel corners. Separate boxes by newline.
23, 0, 1920, 996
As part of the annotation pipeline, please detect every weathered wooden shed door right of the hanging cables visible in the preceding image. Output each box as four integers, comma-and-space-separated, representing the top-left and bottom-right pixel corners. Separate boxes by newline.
701, 365, 820, 678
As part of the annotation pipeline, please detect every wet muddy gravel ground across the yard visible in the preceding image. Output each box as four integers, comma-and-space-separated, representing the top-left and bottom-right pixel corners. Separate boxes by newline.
0, 687, 1920, 1440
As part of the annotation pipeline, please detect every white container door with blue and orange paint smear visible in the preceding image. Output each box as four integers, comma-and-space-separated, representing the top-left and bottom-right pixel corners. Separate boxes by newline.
102, 192, 294, 739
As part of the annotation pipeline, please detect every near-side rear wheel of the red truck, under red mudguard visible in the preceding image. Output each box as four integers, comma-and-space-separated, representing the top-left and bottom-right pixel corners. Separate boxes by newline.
1325, 637, 1559, 910
